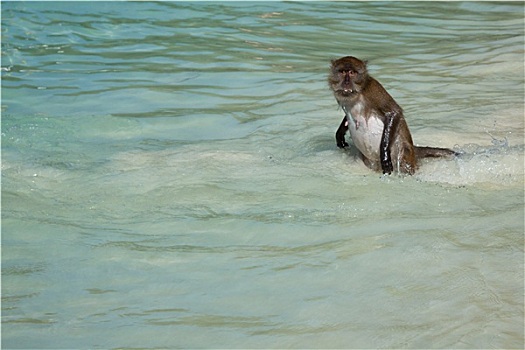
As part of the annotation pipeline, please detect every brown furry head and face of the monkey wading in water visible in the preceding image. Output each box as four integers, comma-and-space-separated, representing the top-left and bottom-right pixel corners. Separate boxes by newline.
328, 56, 368, 101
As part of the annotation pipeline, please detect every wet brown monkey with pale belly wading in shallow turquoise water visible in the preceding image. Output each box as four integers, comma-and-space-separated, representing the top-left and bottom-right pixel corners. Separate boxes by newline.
328, 56, 457, 175
